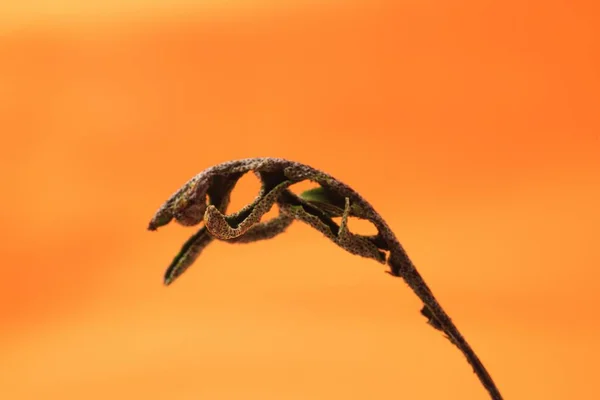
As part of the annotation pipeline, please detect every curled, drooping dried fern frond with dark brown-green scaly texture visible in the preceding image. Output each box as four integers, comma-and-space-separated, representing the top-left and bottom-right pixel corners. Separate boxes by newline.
148, 158, 502, 400
